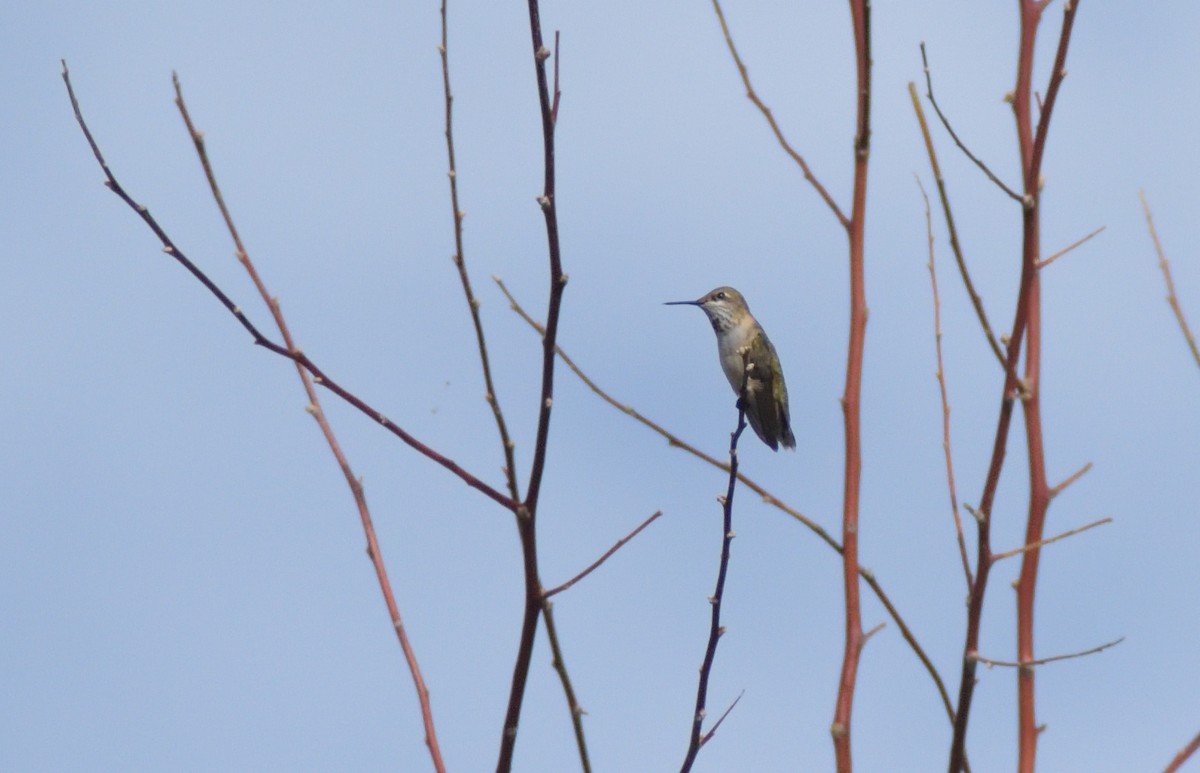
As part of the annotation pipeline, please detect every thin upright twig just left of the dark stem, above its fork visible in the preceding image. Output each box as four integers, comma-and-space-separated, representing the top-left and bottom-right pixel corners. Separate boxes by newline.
438, 0, 521, 501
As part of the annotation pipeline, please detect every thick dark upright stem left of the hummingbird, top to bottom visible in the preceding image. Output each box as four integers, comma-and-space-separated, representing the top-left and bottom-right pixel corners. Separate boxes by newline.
496, 0, 571, 773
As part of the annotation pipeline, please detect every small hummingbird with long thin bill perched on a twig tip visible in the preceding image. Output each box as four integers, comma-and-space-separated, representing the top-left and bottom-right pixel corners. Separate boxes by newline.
666, 287, 796, 451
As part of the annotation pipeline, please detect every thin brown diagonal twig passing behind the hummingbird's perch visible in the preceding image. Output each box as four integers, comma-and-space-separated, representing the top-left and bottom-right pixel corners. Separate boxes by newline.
492, 276, 954, 723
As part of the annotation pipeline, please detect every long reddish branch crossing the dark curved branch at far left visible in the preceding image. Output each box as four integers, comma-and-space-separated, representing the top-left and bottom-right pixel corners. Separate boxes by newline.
168, 65, 445, 773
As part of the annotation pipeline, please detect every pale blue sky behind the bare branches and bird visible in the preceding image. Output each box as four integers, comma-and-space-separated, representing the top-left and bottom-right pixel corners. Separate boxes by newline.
0, 0, 1200, 773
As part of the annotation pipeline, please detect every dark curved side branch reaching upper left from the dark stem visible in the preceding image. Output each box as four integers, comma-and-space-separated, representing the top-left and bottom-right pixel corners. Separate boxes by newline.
62, 64, 518, 510
